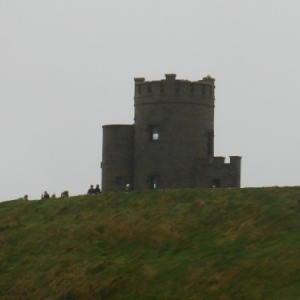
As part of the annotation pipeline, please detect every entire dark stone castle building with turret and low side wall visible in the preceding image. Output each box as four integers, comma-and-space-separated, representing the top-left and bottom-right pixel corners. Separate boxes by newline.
102, 74, 241, 191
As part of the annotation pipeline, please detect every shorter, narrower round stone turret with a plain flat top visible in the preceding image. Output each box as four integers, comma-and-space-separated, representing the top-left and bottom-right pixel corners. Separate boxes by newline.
101, 125, 134, 192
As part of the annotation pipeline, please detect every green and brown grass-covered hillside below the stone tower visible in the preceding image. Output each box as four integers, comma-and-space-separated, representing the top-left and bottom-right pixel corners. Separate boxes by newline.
0, 188, 300, 300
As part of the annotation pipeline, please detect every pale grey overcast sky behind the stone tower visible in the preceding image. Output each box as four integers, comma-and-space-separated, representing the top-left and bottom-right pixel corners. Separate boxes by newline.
0, 0, 300, 201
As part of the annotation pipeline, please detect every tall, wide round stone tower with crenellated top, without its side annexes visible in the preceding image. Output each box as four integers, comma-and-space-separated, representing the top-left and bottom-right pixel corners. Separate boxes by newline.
134, 74, 215, 189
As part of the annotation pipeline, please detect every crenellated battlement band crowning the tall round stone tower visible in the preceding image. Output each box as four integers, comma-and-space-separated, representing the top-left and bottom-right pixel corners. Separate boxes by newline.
134, 74, 215, 104
